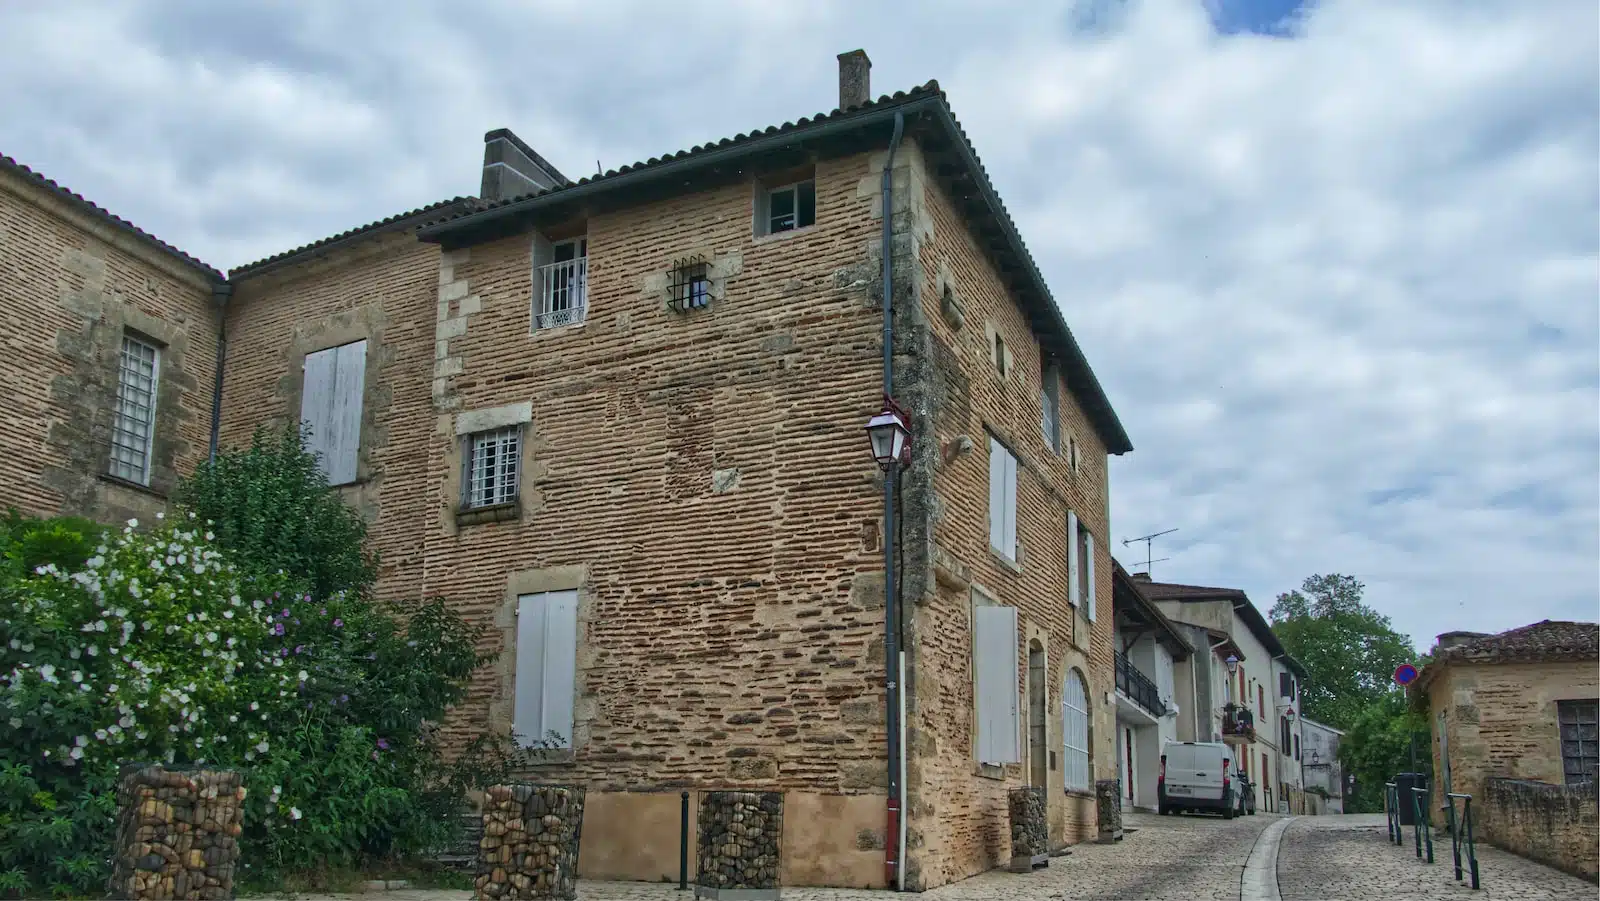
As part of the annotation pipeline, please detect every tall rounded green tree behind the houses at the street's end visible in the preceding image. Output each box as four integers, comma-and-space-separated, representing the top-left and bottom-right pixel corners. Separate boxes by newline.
1272, 573, 1416, 730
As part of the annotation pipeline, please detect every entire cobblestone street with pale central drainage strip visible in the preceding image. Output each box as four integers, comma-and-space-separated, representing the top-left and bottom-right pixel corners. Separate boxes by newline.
281, 815, 1595, 901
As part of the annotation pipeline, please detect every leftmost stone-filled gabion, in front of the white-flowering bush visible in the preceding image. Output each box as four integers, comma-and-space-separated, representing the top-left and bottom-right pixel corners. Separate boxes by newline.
107, 763, 245, 901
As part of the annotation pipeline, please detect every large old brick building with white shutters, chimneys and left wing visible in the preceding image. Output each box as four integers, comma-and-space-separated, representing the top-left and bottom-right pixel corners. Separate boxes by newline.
0, 51, 1131, 890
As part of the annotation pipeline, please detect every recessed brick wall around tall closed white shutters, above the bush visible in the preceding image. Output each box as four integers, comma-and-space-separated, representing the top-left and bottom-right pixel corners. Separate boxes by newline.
222, 230, 440, 599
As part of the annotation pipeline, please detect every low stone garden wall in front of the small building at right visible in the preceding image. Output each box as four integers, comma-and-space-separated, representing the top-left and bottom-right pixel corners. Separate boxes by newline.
1472, 778, 1600, 882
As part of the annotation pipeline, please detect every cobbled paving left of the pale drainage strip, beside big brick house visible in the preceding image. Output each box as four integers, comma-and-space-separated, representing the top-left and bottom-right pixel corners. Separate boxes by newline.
291, 815, 1280, 901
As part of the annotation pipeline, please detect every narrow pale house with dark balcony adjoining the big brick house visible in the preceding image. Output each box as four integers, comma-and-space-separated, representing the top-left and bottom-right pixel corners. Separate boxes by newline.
1112, 560, 1194, 811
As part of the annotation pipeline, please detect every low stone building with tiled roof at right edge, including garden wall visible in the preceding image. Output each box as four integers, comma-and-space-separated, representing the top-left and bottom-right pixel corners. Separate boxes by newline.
1411, 619, 1600, 879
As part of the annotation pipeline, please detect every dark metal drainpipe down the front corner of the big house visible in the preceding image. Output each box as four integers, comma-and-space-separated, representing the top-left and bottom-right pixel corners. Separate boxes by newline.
883, 110, 906, 890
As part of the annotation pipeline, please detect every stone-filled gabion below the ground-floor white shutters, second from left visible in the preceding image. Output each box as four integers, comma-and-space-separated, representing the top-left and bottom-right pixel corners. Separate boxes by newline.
472, 784, 584, 899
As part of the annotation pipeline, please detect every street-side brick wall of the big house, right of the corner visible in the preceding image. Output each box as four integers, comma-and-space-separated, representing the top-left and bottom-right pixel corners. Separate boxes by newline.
910, 151, 1117, 887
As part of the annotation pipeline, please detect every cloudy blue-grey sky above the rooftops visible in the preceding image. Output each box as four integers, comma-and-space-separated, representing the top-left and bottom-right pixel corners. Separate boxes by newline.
0, 0, 1600, 650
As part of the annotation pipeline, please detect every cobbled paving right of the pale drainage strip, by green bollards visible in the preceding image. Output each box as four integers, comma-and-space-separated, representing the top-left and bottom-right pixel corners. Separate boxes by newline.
1278, 813, 1597, 901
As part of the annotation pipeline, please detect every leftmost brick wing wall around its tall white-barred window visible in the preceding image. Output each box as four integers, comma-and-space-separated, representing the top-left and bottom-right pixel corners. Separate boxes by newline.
0, 173, 216, 522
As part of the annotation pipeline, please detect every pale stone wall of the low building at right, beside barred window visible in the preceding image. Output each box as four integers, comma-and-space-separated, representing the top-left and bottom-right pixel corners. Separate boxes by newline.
1427, 661, 1600, 823
